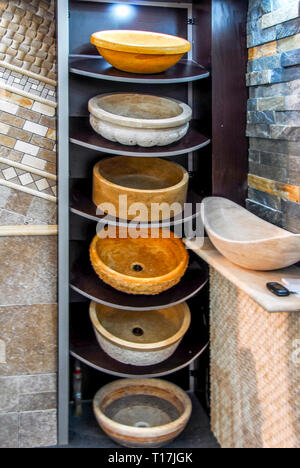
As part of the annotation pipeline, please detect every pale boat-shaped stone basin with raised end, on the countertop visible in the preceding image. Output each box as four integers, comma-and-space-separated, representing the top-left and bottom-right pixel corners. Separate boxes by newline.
202, 197, 300, 271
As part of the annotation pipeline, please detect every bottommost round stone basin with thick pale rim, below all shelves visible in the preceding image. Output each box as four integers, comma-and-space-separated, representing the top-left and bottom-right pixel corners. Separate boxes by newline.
93, 379, 192, 448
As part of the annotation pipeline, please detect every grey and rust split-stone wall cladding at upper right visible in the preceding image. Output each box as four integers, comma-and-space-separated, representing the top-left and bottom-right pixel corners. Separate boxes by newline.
246, 0, 300, 233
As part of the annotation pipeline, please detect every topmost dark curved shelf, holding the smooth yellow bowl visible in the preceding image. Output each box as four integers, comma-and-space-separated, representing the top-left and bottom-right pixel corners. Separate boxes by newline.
70, 56, 210, 84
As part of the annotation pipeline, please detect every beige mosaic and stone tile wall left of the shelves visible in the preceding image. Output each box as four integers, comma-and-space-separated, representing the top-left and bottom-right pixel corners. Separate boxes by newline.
0, 0, 57, 448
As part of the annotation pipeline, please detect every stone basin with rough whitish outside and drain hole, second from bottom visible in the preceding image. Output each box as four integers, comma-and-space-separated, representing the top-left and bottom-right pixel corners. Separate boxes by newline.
90, 302, 191, 366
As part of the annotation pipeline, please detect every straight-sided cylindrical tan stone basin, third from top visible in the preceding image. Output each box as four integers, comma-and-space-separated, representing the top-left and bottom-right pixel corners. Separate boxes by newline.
93, 156, 189, 222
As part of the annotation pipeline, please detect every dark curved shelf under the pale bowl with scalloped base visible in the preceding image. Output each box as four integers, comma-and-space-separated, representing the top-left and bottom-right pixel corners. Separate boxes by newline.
70, 117, 210, 158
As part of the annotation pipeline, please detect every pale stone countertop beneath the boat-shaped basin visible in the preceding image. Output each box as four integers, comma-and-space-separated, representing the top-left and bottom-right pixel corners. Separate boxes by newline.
184, 237, 300, 313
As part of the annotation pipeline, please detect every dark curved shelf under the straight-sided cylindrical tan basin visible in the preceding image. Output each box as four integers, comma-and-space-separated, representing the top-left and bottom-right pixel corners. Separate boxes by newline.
70, 179, 203, 228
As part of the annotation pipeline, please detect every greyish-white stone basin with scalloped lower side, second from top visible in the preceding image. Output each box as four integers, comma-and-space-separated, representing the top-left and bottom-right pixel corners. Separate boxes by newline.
88, 93, 192, 148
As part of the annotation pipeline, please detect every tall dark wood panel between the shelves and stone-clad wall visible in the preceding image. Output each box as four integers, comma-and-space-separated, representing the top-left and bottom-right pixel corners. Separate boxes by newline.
212, 0, 248, 204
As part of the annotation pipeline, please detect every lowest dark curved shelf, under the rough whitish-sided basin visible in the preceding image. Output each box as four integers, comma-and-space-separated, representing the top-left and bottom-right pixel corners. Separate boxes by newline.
70, 305, 209, 377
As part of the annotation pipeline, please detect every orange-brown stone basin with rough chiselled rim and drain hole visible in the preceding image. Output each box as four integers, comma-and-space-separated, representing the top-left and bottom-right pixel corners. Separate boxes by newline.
90, 228, 189, 295
